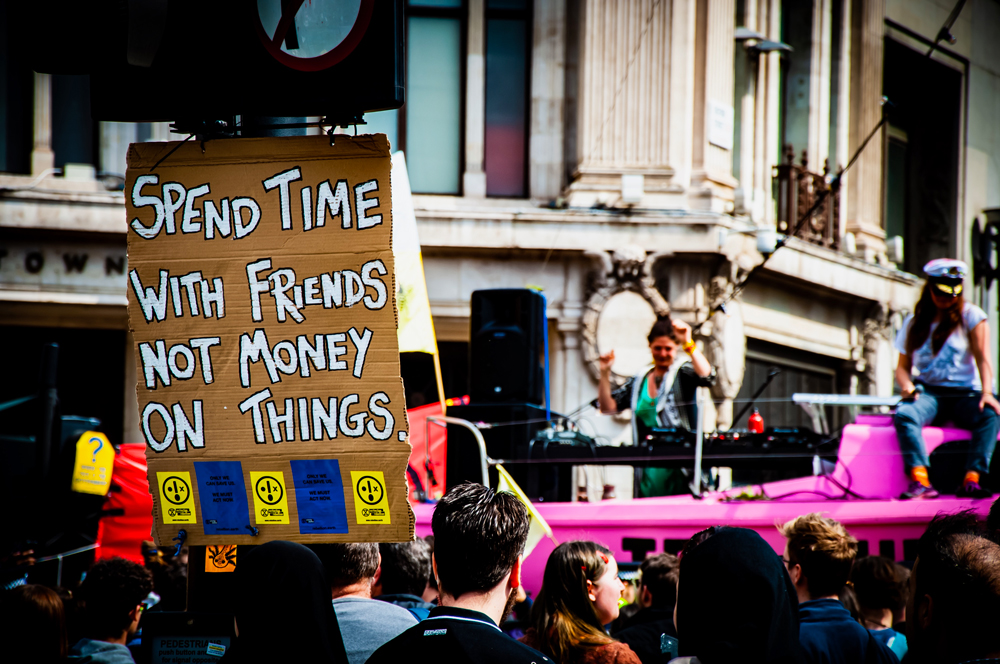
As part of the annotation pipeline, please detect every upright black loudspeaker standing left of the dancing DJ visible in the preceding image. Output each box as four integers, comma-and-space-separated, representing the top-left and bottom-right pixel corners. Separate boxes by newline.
469, 288, 545, 405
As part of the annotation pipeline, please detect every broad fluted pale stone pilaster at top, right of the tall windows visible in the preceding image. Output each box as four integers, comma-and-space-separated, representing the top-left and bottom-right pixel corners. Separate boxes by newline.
569, 0, 688, 207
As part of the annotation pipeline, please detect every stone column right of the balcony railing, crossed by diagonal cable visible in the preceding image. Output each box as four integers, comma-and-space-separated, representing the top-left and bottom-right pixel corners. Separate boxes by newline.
846, 0, 886, 261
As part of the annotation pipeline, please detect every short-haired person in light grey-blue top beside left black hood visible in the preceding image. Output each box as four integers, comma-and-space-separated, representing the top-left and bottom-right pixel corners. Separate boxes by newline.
311, 542, 417, 664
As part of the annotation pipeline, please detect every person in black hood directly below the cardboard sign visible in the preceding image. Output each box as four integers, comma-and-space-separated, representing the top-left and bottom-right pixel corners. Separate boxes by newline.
226, 540, 347, 664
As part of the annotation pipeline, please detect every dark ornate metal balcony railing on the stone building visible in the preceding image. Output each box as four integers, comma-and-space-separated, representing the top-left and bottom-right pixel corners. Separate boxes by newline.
774, 146, 840, 249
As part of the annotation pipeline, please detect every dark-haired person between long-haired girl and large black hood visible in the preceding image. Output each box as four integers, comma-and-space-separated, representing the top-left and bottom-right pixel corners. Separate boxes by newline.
616, 553, 680, 664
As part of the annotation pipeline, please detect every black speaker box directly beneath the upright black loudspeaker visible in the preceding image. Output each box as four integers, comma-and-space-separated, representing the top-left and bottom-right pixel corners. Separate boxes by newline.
446, 403, 561, 489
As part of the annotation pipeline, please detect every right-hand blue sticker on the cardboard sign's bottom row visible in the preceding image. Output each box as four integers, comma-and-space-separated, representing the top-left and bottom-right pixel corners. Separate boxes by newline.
289, 459, 347, 535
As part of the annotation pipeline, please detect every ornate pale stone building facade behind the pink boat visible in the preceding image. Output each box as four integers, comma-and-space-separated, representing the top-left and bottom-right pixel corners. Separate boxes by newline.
0, 0, 1000, 478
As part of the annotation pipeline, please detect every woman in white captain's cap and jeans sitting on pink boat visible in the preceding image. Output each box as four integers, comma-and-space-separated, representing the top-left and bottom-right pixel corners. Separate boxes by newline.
893, 258, 1000, 499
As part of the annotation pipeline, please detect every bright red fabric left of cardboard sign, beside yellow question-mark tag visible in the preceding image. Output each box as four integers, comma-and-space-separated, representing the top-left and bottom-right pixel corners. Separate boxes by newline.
97, 443, 153, 565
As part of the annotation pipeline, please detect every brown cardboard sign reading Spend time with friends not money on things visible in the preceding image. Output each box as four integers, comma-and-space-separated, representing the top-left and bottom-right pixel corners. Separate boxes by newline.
125, 135, 414, 545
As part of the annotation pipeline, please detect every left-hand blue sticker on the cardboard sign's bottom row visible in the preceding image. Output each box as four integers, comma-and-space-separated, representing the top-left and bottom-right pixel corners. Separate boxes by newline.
194, 461, 250, 535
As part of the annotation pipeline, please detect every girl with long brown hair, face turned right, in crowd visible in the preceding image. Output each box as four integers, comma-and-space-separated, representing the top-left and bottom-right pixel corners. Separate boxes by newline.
521, 542, 640, 664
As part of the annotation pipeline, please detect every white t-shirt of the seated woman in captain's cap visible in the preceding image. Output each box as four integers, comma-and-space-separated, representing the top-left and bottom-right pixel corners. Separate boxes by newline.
895, 302, 986, 391
